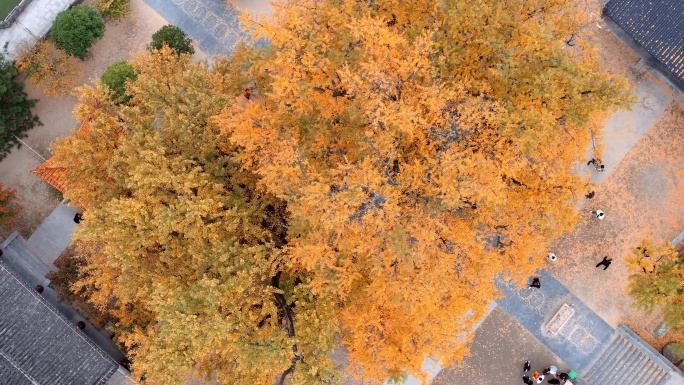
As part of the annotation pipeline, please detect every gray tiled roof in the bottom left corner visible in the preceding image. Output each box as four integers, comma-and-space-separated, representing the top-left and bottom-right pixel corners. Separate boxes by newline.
0, 262, 118, 385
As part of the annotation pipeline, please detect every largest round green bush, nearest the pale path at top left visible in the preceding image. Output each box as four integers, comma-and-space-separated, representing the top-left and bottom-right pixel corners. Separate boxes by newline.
50, 5, 105, 59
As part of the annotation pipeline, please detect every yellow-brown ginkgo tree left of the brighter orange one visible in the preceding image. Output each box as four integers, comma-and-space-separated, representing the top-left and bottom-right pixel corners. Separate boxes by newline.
54, 47, 337, 385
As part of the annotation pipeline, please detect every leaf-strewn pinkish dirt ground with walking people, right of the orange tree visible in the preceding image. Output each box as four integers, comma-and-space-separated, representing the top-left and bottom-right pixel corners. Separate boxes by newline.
553, 103, 684, 348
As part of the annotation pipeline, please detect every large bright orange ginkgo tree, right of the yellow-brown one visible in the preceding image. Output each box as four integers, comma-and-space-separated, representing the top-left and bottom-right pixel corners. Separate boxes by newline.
217, 0, 629, 381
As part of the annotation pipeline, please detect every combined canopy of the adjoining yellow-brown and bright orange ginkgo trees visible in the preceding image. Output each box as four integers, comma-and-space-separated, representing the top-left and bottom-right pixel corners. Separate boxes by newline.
55, 0, 629, 385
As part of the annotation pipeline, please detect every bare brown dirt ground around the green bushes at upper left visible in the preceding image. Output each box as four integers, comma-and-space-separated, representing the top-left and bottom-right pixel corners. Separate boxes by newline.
0, 0, 167, 238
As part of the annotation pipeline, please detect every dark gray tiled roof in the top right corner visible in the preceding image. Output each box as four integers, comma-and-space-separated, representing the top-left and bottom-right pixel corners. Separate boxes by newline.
604, 0, 684, 80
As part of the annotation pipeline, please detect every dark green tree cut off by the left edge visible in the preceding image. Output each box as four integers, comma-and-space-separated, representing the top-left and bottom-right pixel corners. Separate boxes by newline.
0, 53, 41, 159
